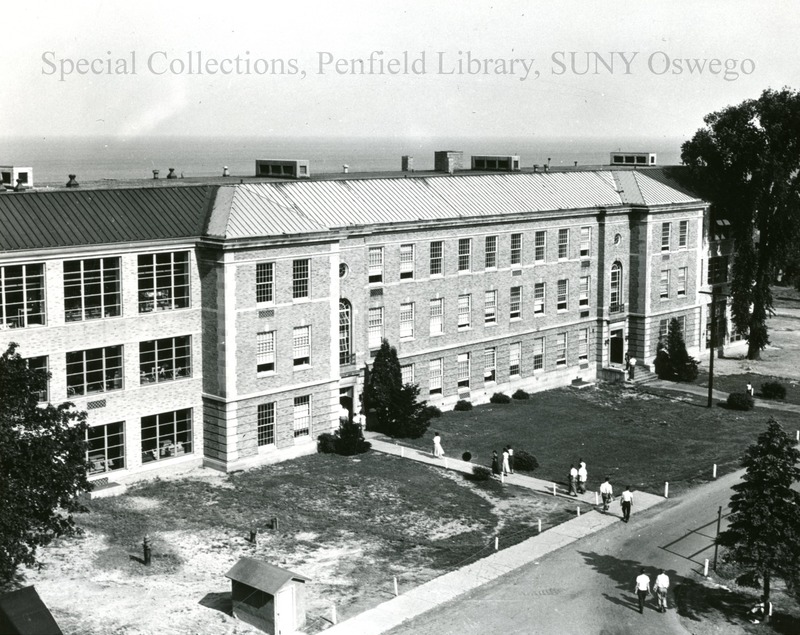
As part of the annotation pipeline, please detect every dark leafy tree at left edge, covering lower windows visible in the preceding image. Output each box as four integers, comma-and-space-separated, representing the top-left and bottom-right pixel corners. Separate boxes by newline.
0, 343, 91, 580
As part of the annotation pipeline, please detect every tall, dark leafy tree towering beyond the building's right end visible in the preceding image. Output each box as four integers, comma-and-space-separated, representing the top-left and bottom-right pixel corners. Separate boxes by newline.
681, 88, 800, 359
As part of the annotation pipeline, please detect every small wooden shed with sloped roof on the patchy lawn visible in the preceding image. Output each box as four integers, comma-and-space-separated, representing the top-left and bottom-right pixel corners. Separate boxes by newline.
225, 558, 310, 635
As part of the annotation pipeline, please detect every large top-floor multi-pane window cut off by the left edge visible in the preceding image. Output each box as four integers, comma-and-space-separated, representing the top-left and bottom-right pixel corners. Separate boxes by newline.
0, 265, 45, 329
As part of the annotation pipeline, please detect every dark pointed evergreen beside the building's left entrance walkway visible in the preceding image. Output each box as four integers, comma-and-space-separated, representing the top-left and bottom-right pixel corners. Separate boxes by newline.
364, 339, 432, 438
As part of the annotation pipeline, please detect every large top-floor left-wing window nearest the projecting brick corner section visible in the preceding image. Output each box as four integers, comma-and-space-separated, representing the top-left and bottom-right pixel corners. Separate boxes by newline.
138, 251, 189, 313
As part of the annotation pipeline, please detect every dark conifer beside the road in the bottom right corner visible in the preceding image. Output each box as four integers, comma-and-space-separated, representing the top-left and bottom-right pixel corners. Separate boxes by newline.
717, 418, 800, 600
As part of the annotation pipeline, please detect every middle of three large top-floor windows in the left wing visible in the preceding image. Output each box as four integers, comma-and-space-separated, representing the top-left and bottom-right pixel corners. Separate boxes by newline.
64, 258, 122, 322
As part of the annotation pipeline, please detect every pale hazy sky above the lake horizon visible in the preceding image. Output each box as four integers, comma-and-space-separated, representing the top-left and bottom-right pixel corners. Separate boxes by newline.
0, 0, 800, 142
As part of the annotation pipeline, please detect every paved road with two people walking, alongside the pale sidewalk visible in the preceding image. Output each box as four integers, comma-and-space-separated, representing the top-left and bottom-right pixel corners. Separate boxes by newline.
389, 472, 741, 635
